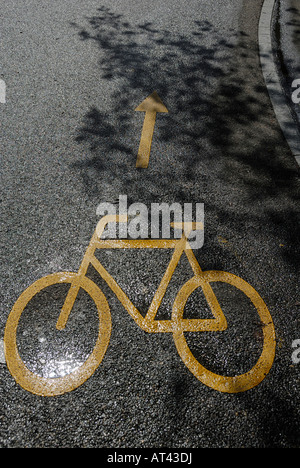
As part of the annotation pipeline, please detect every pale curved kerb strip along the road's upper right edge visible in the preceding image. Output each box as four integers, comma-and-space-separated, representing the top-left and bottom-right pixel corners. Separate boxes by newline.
258, 0, 300, 166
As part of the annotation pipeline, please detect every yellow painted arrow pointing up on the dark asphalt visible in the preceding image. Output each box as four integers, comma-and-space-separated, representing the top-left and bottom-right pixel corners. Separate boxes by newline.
135, 91, 169, 169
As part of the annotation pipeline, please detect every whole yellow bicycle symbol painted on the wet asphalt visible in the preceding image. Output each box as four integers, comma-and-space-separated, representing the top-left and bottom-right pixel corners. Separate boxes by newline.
4, 215, 276, 396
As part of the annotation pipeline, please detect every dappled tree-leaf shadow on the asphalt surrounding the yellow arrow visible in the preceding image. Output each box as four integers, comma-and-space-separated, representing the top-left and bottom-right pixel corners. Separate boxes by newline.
73, 7, 299, 268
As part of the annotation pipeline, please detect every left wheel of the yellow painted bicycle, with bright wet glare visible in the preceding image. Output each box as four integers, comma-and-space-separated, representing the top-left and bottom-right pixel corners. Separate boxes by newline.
4, 272, 111, 396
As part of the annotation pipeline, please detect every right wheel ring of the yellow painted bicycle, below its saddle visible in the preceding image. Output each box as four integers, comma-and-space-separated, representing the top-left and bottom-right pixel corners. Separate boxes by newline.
172, 271, 276, 393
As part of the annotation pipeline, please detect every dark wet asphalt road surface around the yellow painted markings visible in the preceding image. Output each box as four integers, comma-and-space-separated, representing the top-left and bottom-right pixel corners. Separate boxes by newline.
0, 0, 300, 448
